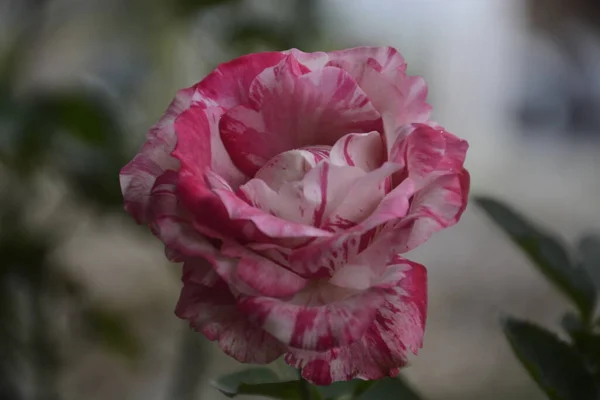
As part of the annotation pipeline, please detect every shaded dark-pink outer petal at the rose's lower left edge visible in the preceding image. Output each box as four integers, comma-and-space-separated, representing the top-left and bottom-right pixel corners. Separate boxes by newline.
175, 262, 285, 364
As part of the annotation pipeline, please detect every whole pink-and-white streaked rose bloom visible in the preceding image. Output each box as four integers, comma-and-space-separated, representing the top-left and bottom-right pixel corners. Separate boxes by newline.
120, 47, 469, 385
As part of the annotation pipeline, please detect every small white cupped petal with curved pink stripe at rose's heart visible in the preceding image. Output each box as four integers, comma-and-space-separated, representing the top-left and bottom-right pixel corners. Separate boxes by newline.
330, 131, 386, 172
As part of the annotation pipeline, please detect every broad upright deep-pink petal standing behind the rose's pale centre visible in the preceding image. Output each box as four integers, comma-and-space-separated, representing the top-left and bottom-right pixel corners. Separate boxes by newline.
221, 56, 381, 175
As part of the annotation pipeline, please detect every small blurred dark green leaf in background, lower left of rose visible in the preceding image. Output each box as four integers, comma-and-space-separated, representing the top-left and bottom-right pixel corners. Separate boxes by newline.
83, 307, 141, 359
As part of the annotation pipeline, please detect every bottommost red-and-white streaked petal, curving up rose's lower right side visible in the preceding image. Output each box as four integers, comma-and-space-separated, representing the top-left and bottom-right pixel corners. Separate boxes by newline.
285, 258, 427, 385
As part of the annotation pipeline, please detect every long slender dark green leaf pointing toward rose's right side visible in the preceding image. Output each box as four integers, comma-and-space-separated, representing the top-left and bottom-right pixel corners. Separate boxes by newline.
475, 197, 596, 320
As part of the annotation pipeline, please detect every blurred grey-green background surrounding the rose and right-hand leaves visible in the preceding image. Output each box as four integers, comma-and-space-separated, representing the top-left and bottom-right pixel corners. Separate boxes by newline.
0, 0, 600, 400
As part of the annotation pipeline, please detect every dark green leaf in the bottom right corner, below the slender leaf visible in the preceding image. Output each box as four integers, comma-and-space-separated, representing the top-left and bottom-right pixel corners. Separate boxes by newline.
503, 318, 597, 400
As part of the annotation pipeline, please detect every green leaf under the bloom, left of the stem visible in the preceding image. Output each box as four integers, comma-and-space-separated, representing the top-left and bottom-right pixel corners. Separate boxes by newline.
212, 367, 301, 400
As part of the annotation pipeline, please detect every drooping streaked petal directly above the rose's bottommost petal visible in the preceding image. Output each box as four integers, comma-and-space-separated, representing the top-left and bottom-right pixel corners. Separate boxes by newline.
239, 288, 383, 351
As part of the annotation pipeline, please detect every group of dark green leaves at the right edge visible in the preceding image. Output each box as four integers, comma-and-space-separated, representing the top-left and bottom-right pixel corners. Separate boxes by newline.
475, 197, 600, 400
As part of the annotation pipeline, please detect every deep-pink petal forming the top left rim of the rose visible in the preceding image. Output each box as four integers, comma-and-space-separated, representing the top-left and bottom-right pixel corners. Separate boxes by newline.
193, 52, 286, 109
